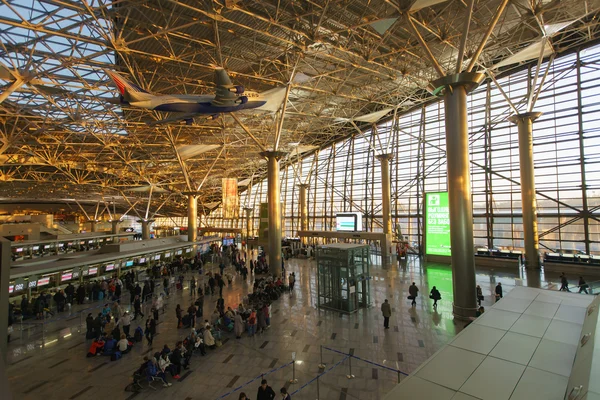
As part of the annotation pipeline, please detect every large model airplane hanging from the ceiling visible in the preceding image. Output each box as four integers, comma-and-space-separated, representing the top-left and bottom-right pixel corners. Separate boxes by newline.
104, 68, 285, 125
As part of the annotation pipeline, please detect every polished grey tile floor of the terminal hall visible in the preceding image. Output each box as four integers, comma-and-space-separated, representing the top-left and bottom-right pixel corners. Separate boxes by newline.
3, 257, 584, 400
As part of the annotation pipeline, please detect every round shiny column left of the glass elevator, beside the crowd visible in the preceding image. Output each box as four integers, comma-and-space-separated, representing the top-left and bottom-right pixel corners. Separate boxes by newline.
260, 151, 285, 276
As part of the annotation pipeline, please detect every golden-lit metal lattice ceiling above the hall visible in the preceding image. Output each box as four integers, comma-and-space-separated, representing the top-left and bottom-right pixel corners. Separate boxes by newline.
0, 0, 600, 215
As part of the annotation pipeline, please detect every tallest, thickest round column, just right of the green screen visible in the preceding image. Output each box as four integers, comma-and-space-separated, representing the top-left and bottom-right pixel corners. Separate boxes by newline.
432, 72, 484, 319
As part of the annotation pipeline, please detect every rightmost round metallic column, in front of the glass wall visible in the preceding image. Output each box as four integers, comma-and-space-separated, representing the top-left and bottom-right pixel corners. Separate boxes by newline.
509, 112, 542, 286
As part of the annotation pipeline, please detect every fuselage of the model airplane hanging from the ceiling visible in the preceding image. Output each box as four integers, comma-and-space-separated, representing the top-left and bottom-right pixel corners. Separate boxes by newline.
128, 92, 267, 114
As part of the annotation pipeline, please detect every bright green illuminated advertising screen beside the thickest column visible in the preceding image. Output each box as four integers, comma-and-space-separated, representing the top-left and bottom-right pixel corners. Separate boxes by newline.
425, 192, 451, 256
